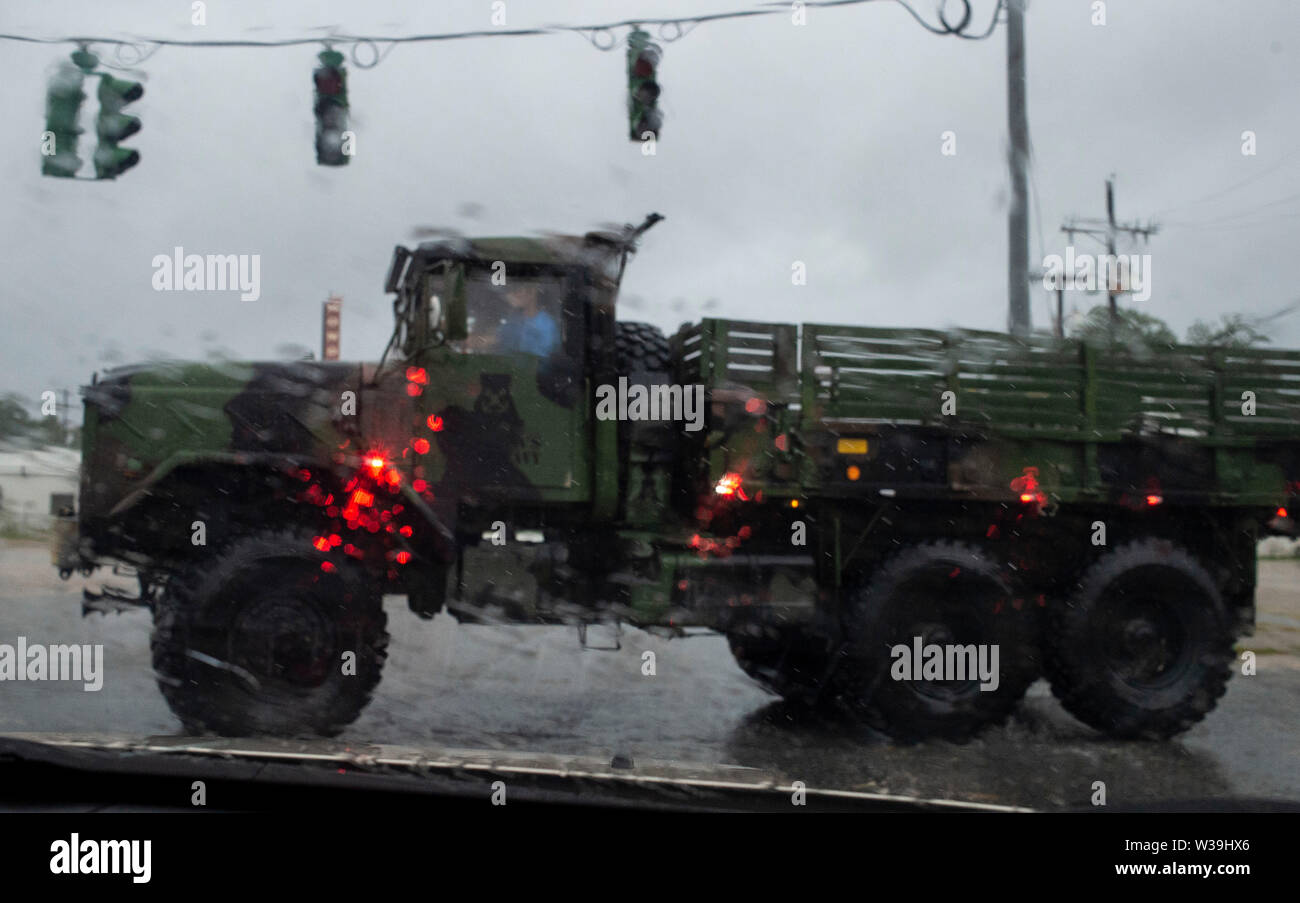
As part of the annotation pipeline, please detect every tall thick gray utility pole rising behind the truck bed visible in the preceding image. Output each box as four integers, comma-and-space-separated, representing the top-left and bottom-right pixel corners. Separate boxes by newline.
1002, 0, 1030, 335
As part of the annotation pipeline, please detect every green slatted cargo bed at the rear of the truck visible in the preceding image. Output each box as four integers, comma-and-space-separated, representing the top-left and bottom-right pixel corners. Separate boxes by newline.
673, 318, 1300, 505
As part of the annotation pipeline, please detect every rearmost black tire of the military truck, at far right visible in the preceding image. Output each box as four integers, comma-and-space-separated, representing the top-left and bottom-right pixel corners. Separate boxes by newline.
1047, 539, 1234, 738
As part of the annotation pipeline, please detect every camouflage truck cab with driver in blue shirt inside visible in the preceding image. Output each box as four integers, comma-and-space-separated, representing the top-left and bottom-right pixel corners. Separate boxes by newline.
371, 224, 655, 533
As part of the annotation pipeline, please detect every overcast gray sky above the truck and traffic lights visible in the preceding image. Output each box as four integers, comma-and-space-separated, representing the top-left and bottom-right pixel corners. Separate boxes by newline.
0, 0, 1300, 410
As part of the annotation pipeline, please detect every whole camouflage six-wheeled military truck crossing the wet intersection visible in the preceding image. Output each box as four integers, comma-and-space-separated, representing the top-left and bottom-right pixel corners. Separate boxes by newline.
56, 214, 1300, 742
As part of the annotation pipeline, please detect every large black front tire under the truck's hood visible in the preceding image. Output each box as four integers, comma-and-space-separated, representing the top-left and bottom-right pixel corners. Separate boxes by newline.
152, 531, 389, 737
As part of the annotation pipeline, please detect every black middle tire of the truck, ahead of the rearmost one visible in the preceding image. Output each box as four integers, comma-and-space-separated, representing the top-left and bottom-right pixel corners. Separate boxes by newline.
836, 542, 1037, 742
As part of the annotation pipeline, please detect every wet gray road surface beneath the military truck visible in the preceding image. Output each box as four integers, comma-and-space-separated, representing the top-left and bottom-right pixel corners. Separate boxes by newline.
0, 541, 1300, 808
